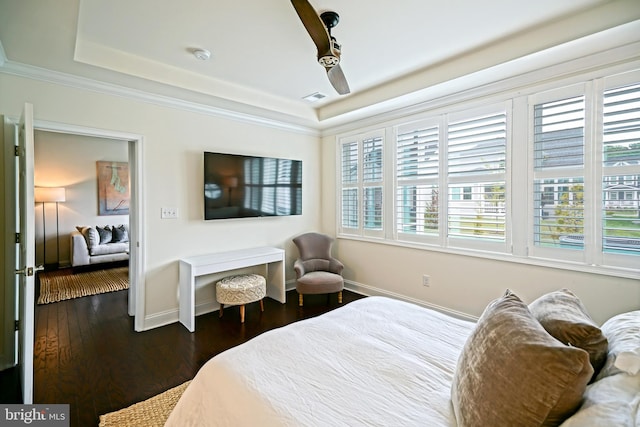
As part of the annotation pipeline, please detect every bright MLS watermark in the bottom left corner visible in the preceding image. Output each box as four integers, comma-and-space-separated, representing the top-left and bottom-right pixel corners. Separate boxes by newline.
0, 404, 69, 427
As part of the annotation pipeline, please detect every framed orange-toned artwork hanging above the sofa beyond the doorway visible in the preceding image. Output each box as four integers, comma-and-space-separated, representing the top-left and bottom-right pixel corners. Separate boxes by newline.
96, 161, 130, 215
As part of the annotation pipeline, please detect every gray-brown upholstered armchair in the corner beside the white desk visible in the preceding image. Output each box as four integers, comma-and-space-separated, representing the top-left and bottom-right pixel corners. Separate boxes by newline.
293, 233, 344, 307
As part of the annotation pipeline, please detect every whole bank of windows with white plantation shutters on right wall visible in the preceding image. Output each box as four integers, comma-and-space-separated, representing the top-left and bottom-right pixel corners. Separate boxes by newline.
338, 67, 640, 274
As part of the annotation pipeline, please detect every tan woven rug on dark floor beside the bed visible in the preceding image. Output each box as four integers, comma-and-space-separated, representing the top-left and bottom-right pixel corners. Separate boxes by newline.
99, 381, 191, 427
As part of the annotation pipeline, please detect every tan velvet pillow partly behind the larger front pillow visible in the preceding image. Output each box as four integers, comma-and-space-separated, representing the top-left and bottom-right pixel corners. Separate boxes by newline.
529, 289, 609, 378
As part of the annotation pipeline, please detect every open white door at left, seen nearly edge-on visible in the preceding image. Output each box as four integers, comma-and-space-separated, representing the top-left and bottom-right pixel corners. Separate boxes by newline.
16, 104, 36, 404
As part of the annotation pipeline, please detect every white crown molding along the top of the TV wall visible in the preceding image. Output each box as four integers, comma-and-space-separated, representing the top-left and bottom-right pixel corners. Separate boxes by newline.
0, 60, 320, 136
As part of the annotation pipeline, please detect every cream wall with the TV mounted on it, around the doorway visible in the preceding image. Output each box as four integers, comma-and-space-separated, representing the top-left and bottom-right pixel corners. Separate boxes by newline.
0, 74, 321, 326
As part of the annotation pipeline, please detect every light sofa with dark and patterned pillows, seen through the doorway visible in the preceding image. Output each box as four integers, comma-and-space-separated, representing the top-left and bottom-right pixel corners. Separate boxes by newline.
71, 225, 129, 267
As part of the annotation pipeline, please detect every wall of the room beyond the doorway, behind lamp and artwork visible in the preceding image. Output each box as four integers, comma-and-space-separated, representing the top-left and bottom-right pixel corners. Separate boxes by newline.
34, 131, 129, 266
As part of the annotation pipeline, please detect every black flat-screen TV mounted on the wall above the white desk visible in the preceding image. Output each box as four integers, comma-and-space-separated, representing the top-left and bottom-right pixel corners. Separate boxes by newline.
204, 152, 302, 220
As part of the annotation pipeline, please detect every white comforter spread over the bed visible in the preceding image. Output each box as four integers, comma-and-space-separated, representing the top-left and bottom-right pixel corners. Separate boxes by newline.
166, 297, 474, 427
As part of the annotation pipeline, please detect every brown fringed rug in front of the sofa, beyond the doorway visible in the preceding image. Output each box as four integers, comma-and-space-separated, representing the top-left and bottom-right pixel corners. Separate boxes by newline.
38, 267, 129, 304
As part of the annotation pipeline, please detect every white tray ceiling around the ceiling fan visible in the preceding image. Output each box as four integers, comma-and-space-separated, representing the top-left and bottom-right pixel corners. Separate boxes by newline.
0, 0, 640, 129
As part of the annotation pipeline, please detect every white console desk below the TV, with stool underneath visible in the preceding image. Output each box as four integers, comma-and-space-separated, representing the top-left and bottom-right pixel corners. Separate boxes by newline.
180, 247, 286, 332
